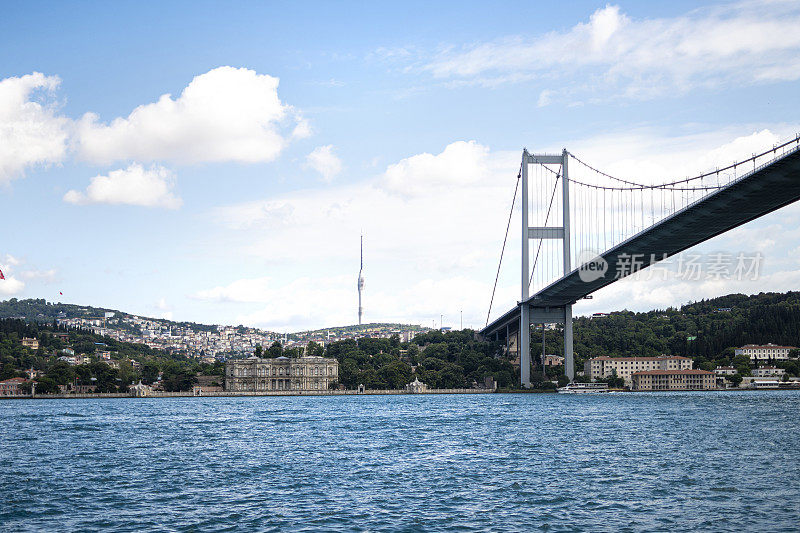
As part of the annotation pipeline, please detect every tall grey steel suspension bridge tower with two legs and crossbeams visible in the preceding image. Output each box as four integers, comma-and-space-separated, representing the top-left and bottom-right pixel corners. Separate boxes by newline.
518, 149, 575, 387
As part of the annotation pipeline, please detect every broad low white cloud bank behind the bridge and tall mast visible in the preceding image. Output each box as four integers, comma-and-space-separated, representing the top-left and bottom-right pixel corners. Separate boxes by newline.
194, 125, 800, 329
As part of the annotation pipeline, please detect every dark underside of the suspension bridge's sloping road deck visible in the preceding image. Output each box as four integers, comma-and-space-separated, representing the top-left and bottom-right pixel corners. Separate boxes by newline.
481, 143, 800, 335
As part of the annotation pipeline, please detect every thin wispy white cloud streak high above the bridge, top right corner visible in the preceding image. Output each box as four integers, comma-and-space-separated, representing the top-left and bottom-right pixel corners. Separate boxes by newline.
422, 1, 800, 98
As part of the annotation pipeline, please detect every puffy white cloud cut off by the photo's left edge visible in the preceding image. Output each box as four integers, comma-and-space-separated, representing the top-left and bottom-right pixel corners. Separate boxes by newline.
0, 72, 69, 183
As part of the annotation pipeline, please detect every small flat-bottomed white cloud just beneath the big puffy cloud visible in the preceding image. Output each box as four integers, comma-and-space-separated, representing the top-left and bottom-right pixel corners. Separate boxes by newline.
64, 163, 183, 209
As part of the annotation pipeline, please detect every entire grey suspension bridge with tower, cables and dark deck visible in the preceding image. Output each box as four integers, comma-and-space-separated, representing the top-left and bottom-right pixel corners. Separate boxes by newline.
480, 135, 800, 386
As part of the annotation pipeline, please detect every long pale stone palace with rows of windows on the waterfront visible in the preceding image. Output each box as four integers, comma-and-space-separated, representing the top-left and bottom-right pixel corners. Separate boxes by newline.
225, 356, 339, 392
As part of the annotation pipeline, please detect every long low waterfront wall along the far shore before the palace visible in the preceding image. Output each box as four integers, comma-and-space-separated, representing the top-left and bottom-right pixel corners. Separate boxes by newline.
0, 389, 495, 400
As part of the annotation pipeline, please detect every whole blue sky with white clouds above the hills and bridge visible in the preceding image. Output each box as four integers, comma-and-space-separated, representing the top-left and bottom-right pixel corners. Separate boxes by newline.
0, 1, 800, 331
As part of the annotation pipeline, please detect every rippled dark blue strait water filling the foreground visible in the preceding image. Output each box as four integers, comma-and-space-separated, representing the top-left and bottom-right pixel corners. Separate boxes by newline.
0, 391, 800, 531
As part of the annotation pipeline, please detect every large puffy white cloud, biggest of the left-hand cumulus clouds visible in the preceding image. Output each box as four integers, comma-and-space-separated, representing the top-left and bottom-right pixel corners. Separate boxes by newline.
76, 67, 311, 164
